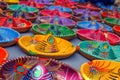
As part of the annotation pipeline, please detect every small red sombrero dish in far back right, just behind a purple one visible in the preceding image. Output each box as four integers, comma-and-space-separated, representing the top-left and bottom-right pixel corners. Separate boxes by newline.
78, 3, 101, 11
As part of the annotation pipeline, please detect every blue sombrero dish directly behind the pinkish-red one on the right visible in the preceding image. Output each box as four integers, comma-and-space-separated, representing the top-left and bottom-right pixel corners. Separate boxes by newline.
77, 21, 112, 31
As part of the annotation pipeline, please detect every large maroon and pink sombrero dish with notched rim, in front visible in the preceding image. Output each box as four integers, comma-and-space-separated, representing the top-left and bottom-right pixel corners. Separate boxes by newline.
0, 56, 83, 80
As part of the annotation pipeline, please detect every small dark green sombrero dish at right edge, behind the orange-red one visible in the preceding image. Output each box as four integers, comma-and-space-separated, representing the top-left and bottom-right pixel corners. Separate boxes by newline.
105, 18, 120, 27
